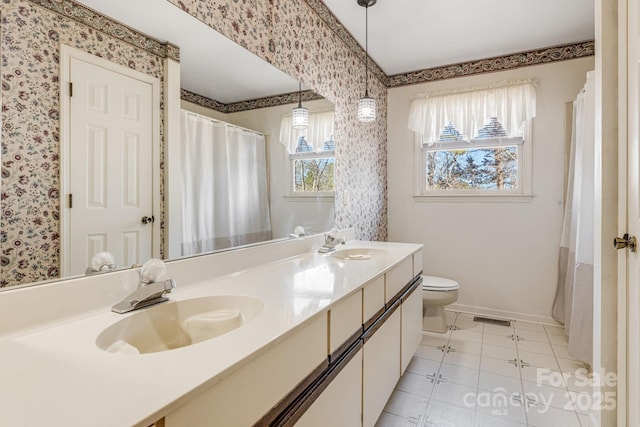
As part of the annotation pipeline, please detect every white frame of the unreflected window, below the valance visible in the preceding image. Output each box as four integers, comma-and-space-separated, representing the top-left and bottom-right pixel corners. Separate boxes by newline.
413, 120, 533, 202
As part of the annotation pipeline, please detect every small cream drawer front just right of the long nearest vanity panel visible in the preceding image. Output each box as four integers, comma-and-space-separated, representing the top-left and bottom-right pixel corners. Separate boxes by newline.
329, 291, 362, 355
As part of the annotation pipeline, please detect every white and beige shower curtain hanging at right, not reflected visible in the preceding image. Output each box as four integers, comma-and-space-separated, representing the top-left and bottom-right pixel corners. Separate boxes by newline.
552, 72, 595, 365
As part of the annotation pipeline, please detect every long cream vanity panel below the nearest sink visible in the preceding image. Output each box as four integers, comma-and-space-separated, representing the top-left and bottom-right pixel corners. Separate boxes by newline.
165, 315, 327, 427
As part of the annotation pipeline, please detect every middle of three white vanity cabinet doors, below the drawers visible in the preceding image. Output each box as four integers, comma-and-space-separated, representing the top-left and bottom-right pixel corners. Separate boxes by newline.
362, 310, 400, 427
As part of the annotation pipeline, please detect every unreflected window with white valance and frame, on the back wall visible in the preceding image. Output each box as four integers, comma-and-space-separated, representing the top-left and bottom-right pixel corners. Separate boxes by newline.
409, 82, 535, 200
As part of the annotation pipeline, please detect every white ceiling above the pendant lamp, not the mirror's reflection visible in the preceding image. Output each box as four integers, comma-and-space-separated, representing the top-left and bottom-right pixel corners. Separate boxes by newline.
323, 0, 595, 75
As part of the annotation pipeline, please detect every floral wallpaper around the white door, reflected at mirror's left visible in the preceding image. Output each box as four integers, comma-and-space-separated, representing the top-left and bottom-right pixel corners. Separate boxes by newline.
0, 0, 166, 287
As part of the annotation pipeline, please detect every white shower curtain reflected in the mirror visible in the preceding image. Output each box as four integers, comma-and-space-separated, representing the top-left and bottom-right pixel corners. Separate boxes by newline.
181, 111, 271, 255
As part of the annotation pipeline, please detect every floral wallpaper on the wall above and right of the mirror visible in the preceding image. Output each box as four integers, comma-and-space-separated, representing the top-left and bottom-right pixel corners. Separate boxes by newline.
167, 0, 387, 244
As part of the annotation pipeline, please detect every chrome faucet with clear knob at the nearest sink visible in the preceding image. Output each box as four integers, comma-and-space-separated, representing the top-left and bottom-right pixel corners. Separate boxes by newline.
111, 258, 176, 314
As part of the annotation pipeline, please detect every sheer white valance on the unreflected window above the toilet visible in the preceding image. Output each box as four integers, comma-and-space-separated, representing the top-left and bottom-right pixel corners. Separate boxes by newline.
408, 81, 536, 145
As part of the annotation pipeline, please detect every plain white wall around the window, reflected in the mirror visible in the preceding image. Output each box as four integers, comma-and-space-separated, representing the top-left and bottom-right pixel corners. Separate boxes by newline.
182, 99, 332, 238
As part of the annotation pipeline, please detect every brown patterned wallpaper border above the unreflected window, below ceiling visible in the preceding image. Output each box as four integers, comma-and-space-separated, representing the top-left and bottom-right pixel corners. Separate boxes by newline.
387, 40, 595, 88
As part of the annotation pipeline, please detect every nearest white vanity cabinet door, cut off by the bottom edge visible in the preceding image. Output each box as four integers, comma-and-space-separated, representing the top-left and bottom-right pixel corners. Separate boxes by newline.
296, 350, 362, 427
